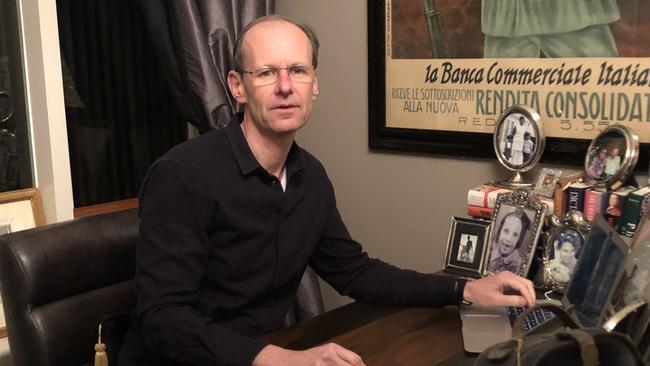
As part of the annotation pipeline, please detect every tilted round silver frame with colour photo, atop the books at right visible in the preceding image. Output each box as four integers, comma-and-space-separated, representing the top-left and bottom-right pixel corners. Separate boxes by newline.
584, 124, 639, 190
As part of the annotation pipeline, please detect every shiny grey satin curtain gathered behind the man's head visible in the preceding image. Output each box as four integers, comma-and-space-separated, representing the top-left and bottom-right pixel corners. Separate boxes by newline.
140, 0, 275, 133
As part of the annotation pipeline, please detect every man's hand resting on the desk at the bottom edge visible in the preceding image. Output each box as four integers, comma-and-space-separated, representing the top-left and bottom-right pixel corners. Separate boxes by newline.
252, 343, 366, 366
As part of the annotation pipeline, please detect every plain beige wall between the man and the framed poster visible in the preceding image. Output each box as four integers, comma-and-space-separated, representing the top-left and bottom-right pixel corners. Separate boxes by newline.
276, 0, 584, 309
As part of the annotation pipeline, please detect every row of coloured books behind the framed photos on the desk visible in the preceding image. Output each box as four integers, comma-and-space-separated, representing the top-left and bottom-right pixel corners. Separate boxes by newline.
467, 182, 650, 237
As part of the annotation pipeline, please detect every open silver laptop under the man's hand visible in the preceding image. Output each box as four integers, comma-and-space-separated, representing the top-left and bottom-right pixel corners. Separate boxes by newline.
460, 215, 629, 353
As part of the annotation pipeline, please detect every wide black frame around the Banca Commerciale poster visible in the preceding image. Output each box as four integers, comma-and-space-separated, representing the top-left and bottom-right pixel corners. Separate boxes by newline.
366, 0, 650, 170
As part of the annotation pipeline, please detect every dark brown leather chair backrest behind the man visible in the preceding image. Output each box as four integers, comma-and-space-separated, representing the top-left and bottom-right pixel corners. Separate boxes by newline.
0, 209, 138, 366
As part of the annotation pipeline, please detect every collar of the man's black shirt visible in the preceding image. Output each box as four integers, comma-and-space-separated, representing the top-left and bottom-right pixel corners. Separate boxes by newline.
226, 112, 305, 180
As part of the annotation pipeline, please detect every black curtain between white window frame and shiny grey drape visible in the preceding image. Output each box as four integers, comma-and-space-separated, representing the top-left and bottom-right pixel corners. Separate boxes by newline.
57, 0, 187, 207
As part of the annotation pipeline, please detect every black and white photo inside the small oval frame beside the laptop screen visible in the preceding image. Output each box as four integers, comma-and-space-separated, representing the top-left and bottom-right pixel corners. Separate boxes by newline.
548, 228, 584, 285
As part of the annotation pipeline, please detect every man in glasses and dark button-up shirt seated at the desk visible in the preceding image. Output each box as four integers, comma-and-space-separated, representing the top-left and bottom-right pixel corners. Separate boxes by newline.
121, 16, 534, 366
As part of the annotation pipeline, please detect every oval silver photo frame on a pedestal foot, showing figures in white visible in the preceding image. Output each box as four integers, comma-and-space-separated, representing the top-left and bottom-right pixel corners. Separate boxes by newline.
493, 105, 545, 187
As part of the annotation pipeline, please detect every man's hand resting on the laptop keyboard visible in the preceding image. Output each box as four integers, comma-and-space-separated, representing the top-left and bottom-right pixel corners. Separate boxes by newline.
463, 271, 535, 306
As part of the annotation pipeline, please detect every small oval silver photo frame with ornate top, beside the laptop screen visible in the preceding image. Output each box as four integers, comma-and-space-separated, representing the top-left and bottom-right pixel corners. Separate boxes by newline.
542, 211, 591, 292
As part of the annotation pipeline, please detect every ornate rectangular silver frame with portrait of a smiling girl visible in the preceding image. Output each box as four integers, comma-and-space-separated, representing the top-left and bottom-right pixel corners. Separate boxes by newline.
483, 189, 546, 277
